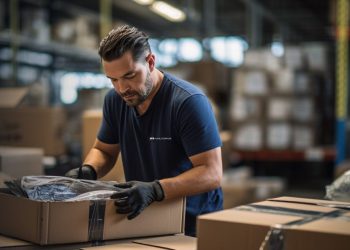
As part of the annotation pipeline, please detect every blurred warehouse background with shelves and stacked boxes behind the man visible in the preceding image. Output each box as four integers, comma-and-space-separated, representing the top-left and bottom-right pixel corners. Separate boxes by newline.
0, 0, 350, 207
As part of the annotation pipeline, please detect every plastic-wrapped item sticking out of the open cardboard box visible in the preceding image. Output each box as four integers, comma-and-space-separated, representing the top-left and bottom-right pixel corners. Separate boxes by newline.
6, 176, 118, 201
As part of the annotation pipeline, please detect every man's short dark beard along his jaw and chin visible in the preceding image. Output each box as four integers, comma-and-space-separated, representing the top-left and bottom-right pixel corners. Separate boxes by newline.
121, 72, 153, 107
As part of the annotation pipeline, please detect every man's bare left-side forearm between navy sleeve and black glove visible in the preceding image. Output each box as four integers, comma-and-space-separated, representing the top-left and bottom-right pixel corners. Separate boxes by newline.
83, 148, 118, 178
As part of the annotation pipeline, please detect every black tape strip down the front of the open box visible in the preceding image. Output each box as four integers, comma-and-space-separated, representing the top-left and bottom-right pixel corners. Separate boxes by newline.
88, 200, 106, 242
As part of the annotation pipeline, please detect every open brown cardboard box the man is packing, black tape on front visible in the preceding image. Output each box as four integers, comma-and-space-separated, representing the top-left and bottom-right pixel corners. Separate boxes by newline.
0, 193, 185, 245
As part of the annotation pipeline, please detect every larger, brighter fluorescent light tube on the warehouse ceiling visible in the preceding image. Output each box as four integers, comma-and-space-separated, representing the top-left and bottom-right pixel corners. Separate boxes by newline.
150, 1, 186, 22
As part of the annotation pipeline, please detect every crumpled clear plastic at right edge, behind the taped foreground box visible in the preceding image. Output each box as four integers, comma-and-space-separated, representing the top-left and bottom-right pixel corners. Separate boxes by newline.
326, 170, 350, 202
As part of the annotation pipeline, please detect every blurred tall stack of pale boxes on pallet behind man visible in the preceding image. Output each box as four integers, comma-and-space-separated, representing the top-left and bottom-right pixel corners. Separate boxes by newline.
230, 45, 326, 150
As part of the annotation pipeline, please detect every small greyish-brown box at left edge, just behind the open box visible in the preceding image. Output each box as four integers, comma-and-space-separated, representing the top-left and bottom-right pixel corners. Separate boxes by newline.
0, 146, 44, 178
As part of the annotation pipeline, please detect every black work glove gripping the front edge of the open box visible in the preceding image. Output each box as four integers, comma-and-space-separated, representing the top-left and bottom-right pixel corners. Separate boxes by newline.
111, 181, 164, 220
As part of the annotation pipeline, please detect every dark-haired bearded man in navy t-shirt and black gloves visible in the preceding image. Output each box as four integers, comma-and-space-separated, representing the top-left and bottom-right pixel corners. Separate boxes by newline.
66, 26, 222, 235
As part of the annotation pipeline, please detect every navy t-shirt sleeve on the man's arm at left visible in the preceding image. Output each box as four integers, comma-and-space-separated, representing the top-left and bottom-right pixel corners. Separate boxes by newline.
97, 92, 119, 144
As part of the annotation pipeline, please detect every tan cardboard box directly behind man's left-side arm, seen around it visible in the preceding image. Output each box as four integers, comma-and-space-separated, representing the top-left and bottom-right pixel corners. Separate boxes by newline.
82, 110, 125, 182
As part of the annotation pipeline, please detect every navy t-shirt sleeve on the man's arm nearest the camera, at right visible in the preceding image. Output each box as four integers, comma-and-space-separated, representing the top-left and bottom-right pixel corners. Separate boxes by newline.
178, 94, 221, 156
